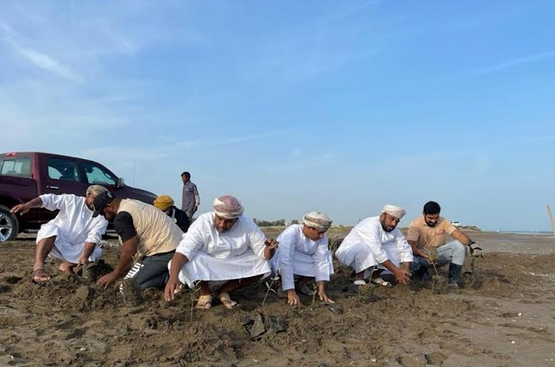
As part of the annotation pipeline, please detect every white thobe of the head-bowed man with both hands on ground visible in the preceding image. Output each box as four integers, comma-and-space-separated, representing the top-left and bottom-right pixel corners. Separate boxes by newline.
272, 224, 333, 291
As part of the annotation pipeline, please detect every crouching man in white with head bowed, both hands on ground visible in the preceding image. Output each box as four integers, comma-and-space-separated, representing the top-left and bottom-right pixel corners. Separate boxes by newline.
272, 212, 334, 305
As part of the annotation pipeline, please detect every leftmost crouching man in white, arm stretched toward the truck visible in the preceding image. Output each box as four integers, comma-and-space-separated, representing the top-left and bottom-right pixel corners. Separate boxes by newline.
11, 185, 108, 283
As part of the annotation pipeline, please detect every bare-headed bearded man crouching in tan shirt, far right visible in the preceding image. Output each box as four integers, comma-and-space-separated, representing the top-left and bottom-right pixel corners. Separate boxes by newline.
407, 201, 482, 288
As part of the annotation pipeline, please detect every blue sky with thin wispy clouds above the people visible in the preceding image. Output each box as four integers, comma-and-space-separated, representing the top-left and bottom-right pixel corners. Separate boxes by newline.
0, 0, 555, 230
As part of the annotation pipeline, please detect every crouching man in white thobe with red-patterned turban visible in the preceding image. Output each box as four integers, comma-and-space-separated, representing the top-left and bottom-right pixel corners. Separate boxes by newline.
164, 195, 277, 309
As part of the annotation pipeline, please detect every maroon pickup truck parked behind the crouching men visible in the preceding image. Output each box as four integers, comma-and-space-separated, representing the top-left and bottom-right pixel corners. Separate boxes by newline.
0, 152, 156, 242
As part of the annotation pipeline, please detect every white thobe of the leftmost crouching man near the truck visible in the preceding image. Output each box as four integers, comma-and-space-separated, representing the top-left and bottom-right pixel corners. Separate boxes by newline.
37, 194, 108, 263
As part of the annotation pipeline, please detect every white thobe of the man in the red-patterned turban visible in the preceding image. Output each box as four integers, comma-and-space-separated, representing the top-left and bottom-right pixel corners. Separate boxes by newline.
173, 212, 271, 287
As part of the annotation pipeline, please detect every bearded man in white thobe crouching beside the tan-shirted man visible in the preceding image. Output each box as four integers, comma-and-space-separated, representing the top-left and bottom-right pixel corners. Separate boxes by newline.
335, 205, 412, 286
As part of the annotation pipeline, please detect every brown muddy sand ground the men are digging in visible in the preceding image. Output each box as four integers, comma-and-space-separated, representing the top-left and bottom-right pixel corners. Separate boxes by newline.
0, 231, 555, 367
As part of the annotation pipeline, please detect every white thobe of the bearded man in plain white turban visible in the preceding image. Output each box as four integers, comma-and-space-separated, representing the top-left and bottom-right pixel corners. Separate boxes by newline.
335, 217, 413, 273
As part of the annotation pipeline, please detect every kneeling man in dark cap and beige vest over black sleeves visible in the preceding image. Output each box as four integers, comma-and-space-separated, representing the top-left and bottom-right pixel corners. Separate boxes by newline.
93, 192, 183, 296
